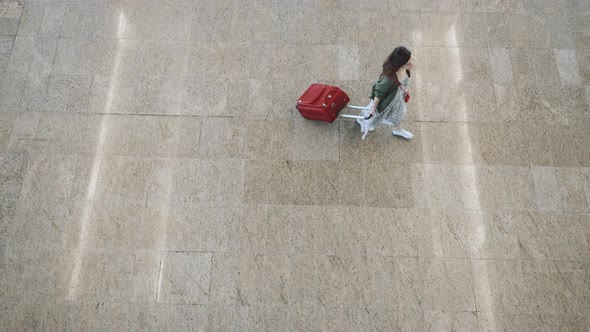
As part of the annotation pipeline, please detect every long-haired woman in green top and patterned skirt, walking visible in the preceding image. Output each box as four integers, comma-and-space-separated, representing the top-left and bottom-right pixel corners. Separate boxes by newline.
357, 46, 414, 139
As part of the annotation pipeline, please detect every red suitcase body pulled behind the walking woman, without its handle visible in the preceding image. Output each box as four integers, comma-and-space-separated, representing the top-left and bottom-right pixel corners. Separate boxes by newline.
297, 83, 350, 123
